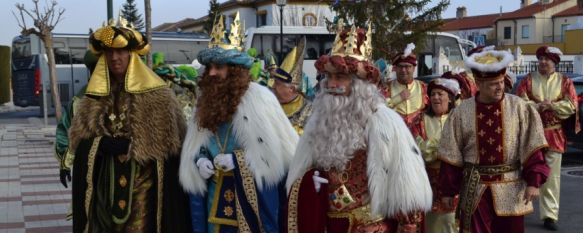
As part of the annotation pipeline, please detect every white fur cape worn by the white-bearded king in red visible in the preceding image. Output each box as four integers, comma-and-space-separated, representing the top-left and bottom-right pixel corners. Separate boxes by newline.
286, 104, 432, 217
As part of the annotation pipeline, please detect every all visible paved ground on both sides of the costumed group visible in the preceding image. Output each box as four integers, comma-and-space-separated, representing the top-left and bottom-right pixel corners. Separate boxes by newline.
0, 106, 583, 233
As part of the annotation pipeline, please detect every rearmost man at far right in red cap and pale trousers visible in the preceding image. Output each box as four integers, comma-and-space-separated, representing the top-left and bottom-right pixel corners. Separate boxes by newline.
516, 46, 579, 230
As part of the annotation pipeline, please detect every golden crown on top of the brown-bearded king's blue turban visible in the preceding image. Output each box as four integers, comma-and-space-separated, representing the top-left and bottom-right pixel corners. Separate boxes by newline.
209, 11, 245, 51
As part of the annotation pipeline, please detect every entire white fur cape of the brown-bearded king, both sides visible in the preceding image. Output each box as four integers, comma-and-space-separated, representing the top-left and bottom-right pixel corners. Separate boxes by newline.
179, 83, 298, 194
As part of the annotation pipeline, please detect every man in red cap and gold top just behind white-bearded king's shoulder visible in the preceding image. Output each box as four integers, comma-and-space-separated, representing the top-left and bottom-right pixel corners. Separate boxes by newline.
384, 43, 429, 129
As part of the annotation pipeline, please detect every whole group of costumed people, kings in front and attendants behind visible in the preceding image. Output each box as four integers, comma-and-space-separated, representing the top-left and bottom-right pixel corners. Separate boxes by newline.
55, 15, 579, 233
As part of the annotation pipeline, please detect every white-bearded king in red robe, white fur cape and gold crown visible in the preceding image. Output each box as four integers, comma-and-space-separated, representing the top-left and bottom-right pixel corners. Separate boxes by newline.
286, 23, 431, 233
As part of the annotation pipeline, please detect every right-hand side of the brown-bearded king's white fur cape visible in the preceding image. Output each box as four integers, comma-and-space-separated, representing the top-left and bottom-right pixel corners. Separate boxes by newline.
233, 83, 299, 190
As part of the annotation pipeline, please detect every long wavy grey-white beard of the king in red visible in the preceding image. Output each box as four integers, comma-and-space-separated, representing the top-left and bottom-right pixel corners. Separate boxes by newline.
304, 78, 384, 169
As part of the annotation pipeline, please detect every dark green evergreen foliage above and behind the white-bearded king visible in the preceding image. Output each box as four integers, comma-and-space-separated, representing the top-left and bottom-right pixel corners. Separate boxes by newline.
327, 0, 449, 59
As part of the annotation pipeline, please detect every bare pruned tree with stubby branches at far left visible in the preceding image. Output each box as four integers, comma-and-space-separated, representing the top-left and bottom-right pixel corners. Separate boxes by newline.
12, 0, 65, 121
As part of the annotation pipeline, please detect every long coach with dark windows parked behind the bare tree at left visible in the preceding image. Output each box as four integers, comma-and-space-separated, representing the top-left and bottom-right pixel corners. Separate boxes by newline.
11, 32, 209, 113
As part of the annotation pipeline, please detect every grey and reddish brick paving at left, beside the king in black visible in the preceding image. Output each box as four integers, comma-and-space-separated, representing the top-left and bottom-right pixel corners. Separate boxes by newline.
0, 121, 71, 233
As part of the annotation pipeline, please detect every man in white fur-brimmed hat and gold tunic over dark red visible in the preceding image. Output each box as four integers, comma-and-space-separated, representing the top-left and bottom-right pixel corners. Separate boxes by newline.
438, 51, 549, 233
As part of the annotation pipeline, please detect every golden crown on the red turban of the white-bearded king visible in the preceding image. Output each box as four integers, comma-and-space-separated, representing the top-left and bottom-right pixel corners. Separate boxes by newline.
331, 19, 372, 61
